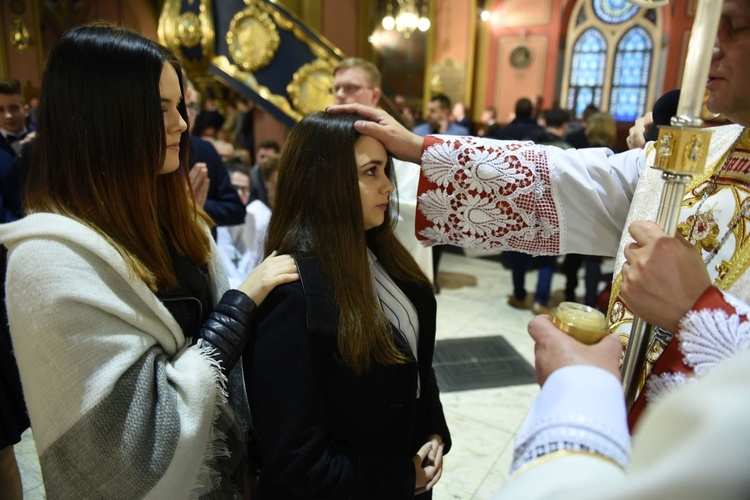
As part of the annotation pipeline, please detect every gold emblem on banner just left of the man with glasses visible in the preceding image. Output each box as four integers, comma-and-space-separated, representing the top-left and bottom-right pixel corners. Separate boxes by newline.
286, 59, 334, 115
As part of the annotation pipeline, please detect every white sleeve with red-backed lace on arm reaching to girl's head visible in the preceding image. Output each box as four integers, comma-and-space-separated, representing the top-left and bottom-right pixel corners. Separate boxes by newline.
418, 136, 643, 255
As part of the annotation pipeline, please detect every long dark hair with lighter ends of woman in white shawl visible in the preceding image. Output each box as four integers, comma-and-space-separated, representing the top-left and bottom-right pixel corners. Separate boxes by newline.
25, 24, 211, 291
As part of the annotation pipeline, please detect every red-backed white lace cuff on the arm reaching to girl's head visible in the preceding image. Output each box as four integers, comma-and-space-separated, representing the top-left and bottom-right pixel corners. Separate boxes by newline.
417, 136, 561, 255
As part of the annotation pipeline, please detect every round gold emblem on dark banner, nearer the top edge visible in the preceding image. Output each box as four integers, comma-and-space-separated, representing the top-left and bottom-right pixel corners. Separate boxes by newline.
227, 2, 281, 72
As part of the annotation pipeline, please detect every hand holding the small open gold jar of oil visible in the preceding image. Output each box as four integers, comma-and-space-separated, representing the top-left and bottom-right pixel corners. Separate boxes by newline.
528, 315, 622, 386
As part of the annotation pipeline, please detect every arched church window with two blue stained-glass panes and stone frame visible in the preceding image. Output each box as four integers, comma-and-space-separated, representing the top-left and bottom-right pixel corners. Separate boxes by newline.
561, 0, 662, 121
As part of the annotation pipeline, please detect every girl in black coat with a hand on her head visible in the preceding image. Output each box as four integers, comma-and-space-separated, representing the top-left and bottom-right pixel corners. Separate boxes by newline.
247, 113, 450, 499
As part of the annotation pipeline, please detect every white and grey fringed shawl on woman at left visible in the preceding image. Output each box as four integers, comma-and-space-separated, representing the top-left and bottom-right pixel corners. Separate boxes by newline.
0, 214, 245, 500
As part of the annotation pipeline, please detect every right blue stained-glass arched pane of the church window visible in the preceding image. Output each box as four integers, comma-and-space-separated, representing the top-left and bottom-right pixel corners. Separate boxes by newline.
609, 26, 654, 121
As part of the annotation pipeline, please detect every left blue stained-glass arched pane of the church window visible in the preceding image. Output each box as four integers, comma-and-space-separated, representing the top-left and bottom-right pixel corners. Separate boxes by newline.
567, 28, 607, 115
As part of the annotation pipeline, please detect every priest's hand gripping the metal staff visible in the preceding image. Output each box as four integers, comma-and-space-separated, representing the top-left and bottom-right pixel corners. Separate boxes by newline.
620, 221, 711, 333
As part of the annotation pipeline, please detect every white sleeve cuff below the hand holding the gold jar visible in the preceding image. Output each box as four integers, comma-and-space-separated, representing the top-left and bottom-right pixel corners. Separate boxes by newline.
510, 366, 630, 474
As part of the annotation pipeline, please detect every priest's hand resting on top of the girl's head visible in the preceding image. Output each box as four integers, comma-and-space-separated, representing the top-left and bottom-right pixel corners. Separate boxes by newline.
326, 104, 424, 163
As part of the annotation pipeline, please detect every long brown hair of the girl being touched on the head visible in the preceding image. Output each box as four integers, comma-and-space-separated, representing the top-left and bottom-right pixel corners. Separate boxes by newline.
266, 112, 429, 373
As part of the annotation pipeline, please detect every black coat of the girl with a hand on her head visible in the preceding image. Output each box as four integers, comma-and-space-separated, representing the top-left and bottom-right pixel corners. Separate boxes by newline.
245, 257, 451, 500
